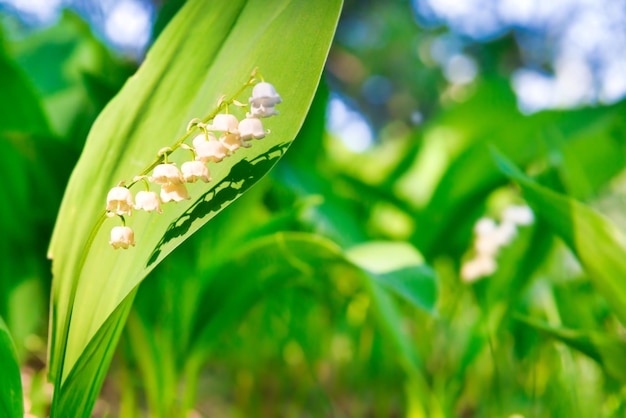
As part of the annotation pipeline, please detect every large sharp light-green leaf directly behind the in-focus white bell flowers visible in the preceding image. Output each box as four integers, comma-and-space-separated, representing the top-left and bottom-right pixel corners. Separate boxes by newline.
50, 0, 341, 416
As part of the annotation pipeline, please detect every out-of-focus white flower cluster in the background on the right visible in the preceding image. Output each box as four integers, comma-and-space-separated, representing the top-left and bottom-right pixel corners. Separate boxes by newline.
461, 206, 534, 282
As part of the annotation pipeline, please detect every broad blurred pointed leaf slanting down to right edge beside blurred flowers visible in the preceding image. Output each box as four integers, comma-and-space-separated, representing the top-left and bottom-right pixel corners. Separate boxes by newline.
496, 155, 626, 324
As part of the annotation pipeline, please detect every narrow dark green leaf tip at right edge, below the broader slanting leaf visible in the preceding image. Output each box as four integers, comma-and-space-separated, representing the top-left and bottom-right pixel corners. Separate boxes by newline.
518, 317, 626, 382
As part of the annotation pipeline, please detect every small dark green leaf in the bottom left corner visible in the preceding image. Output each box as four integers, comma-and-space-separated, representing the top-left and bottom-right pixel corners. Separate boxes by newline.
0, 318, 24, 418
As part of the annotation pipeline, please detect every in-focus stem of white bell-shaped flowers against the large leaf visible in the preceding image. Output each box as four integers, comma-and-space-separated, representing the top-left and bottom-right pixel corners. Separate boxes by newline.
106, 76, 282, 249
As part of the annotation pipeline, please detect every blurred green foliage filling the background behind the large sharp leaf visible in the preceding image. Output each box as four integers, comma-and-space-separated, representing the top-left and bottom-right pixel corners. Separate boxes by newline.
0, 2, 626, 417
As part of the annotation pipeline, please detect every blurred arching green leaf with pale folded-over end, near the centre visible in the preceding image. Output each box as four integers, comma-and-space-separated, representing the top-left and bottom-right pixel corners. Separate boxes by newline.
192, 232, 438, 416
